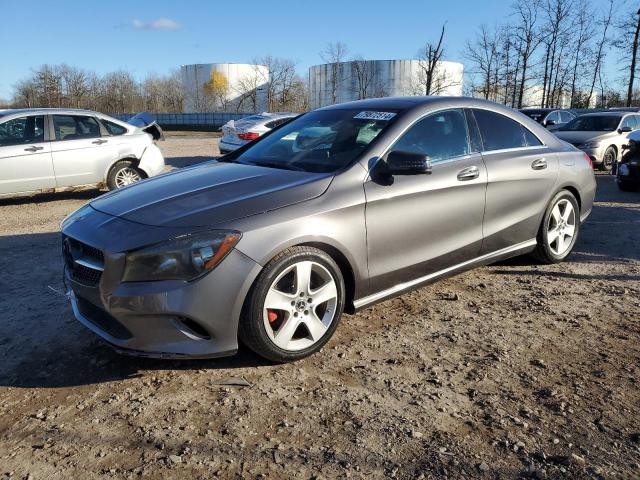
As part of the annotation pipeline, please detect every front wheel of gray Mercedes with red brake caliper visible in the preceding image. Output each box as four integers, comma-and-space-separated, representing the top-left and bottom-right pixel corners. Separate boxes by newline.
238, 246, 345, 363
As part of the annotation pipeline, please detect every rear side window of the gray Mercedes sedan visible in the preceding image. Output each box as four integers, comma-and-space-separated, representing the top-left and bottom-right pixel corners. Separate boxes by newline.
473, 109, 542, 151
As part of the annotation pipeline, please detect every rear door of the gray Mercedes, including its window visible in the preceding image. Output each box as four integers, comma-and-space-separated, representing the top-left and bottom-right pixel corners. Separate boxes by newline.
473, 108, 558, 254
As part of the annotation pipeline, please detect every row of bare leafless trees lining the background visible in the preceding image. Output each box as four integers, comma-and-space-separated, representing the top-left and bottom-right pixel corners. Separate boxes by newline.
7, 0, 640, 113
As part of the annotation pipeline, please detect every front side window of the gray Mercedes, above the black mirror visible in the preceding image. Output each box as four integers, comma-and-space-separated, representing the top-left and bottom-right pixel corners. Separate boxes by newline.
391, 109, 470, 163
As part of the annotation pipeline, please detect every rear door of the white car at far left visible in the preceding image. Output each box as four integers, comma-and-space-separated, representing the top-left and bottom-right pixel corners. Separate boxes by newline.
51, 115, 115, 187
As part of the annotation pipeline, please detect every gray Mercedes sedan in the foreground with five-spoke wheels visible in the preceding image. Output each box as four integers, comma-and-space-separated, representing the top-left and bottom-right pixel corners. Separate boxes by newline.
62, 97, 595, 361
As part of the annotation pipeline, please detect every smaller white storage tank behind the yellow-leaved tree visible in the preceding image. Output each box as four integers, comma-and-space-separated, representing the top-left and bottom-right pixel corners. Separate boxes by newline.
180, 63, 269, 113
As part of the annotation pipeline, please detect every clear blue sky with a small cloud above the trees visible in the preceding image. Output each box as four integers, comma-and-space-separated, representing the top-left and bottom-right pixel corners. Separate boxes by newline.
0, 0, 620, 99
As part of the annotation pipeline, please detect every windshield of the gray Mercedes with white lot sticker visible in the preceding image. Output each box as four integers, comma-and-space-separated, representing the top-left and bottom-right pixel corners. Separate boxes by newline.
229, 109, 398, 173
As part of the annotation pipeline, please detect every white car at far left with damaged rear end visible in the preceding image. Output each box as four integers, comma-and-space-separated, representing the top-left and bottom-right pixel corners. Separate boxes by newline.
0, 108, 164, 195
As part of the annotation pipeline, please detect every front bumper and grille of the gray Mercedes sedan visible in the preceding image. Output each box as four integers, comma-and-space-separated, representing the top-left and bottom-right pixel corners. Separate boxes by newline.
62, 207, 262, 358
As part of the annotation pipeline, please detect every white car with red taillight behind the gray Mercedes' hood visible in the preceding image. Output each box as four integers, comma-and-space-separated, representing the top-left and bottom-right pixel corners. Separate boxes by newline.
219, 112, 300, 154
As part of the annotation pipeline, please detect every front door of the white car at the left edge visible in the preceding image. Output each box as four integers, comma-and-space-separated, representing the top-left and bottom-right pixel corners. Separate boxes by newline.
0, 115, 56, 194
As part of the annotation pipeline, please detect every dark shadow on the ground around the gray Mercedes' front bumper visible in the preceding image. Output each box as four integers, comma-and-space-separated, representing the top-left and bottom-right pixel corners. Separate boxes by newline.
0, 232, 270, 388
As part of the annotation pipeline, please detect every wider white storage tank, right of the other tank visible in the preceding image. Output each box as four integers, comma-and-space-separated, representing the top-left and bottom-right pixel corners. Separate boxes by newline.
309, 60, 464, 108
